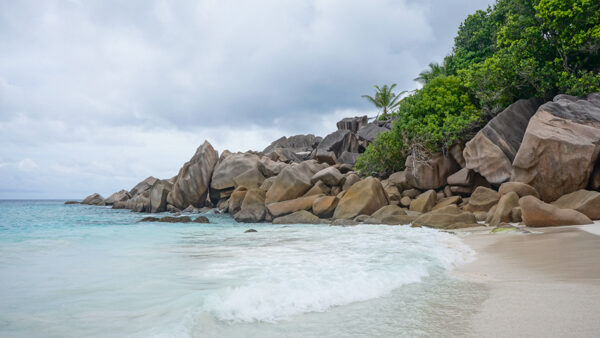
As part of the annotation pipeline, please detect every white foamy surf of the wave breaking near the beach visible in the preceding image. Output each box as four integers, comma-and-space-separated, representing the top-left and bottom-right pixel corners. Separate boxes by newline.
204, 225, 474, 322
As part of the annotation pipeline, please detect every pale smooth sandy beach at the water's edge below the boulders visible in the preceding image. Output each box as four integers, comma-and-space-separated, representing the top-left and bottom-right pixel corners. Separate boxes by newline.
453, 223, 600, 337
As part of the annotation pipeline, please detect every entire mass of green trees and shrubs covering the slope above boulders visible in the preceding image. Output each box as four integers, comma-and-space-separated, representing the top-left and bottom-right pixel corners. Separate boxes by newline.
357, 0, 600, 175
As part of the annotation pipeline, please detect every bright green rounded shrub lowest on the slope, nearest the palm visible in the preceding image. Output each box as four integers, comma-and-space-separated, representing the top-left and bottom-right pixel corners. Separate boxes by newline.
355, 75, 479, 176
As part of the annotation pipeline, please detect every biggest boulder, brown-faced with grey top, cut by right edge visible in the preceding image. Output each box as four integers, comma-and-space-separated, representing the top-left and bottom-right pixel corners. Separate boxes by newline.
511, 93, 600, 202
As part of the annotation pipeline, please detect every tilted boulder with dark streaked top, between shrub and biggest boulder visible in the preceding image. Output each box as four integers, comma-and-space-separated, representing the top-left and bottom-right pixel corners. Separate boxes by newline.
463, 99, 541, 185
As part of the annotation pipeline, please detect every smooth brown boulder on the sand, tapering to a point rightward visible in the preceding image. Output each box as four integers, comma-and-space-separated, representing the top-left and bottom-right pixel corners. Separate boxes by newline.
519, 196, 592, 227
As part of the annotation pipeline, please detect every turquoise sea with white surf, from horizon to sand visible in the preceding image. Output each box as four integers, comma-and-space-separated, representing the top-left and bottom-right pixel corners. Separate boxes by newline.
0, 201, 485, 337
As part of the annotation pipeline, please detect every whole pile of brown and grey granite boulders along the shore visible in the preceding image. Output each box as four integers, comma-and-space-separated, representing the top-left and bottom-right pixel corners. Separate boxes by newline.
82, 93, 600, 229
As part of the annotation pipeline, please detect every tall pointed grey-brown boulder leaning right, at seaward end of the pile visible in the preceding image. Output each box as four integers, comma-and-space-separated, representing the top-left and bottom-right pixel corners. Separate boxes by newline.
167, 141, 219, 209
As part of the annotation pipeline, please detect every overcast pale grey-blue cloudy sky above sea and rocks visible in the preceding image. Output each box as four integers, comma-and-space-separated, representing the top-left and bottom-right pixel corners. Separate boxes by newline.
0, 0, 493, 199
